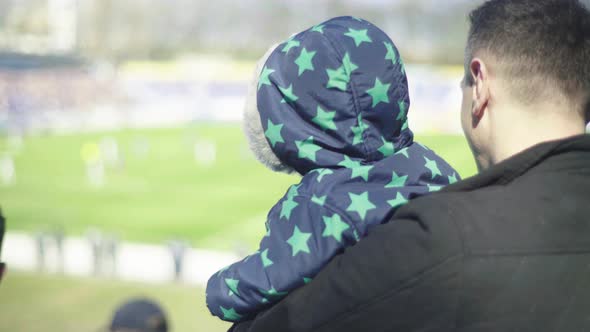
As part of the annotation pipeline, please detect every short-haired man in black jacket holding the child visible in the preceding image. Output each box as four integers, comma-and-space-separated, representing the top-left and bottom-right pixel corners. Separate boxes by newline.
234, 0, 590, 332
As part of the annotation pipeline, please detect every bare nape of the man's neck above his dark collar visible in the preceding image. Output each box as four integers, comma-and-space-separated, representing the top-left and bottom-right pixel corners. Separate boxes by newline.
491, 104, 586, 165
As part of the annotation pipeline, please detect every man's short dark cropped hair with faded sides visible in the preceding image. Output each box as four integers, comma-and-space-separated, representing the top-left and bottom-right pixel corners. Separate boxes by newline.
465, 0, 590, 115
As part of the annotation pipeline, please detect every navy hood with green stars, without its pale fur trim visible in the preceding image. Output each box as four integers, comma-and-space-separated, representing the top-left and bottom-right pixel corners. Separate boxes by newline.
257, 17, 413, 175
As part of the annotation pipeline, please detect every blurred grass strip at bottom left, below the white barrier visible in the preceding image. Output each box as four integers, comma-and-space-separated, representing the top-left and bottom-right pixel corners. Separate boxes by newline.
0, 271, 230, 332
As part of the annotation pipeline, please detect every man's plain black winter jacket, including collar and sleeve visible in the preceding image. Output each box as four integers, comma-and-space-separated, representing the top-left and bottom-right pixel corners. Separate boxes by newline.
234, 135, 590, 332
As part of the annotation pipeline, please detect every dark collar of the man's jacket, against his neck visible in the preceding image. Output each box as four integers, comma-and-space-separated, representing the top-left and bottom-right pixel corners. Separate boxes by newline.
442, 135, 590, 192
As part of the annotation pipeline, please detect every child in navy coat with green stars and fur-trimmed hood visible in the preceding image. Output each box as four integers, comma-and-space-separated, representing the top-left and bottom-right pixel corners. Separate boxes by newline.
207, 17, 458, 322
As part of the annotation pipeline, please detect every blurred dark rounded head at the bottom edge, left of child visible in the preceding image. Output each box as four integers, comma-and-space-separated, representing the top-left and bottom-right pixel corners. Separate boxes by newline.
108, 298, 168, 332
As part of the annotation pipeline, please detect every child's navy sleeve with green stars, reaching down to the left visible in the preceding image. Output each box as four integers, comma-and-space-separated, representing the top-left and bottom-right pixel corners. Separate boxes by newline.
207, 190, 356, 322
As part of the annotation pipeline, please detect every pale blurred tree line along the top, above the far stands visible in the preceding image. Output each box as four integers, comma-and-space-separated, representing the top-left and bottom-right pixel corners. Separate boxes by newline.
0, 0, 590, 64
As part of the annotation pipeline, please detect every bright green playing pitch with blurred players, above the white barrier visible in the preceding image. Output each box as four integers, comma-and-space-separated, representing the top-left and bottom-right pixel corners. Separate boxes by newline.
0, 124, 475, 249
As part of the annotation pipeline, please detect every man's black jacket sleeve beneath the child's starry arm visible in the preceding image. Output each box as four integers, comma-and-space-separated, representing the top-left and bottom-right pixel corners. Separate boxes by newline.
232, 198, 462, 332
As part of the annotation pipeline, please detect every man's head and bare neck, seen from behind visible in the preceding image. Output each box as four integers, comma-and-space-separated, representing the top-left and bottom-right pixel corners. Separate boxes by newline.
461, 0, 590, 169
